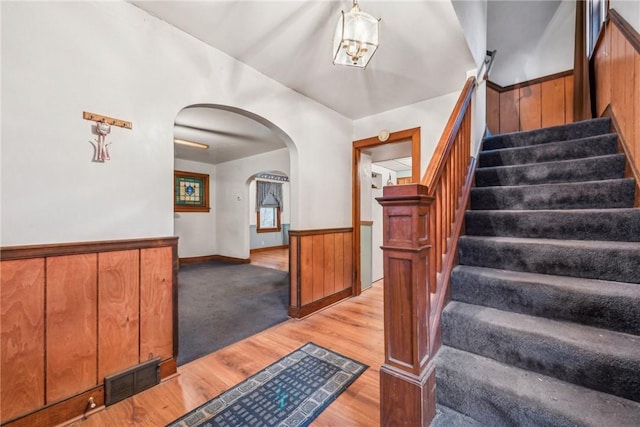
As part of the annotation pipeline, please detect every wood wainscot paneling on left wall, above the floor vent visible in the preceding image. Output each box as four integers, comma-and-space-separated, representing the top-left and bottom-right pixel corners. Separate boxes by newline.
0, 237, 177, 426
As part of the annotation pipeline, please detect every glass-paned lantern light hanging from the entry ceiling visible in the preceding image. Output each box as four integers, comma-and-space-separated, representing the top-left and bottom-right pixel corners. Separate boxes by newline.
333, 3, 380, 68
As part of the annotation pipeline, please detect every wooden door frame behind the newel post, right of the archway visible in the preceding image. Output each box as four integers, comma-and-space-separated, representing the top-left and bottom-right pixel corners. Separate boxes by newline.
351, 127, 420, 295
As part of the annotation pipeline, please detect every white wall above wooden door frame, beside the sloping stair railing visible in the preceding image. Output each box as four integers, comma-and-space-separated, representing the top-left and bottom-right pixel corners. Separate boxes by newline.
353, 88, 462, 178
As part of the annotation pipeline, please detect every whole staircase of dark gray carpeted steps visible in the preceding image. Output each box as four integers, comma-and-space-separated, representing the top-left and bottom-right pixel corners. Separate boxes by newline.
431, 119, 640, 427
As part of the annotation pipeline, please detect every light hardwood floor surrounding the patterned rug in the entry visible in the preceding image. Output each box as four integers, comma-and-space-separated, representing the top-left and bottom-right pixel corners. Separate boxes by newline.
69, 281, 384, 427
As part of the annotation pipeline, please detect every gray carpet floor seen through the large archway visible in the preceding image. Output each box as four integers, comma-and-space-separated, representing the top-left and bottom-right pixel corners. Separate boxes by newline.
178, 261, 289, 366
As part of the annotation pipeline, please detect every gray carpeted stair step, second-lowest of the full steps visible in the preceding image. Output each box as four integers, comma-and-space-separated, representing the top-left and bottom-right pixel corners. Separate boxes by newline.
442, 301, 640, 401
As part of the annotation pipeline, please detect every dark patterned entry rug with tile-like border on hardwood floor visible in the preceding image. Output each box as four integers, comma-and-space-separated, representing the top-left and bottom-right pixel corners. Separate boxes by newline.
169, 343, 368, 427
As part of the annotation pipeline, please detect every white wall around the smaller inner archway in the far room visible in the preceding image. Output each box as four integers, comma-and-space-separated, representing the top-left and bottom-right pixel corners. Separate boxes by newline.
214, 149, 288, 258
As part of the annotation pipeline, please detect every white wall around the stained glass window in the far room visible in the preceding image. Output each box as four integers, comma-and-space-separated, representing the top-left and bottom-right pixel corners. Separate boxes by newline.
173, 159, 217, 258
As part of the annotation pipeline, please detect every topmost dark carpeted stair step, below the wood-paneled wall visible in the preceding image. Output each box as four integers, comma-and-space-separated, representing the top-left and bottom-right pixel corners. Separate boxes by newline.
483, 118, 611, 150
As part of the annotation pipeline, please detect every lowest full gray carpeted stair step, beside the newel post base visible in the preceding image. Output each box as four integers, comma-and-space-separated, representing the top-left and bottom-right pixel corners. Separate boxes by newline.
435, 346, 640, 427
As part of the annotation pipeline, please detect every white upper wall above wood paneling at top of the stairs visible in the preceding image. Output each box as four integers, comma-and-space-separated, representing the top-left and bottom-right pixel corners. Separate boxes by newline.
487, 0, 575, 86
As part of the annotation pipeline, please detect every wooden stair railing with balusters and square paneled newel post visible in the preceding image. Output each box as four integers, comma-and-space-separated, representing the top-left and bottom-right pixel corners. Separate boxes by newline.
378, 77, 476, 426
